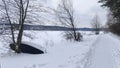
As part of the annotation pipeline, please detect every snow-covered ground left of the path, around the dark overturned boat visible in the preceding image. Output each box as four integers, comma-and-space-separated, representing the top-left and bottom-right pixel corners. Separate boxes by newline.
0, 31, 97, 68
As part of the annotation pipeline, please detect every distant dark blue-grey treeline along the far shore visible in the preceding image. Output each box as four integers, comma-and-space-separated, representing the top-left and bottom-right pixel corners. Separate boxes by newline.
0, 24, 101, 31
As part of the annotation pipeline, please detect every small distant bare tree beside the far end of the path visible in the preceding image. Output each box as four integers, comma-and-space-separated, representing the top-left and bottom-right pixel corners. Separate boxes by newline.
91, 14, 101, 34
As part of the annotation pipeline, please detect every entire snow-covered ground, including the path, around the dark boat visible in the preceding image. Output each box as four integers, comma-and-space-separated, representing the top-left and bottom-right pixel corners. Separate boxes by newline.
0, 31, 120, 68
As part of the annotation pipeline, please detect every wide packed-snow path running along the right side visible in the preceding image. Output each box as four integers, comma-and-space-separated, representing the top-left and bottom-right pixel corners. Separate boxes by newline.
84, 35, 120, 68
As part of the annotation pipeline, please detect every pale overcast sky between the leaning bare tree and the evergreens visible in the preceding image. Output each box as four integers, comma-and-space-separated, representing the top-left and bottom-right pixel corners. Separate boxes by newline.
48, 0, 107, 27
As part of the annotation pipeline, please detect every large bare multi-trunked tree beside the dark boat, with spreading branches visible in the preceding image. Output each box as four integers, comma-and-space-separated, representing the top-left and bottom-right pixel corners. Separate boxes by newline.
0, 0, 55, 53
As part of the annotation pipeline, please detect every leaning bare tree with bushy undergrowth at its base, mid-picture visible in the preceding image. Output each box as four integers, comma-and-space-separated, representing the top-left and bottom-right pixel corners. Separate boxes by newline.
56, 0, 82, 41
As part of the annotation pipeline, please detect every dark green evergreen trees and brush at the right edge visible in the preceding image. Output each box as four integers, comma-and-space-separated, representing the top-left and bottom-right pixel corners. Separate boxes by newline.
99, 0, 120, 35
